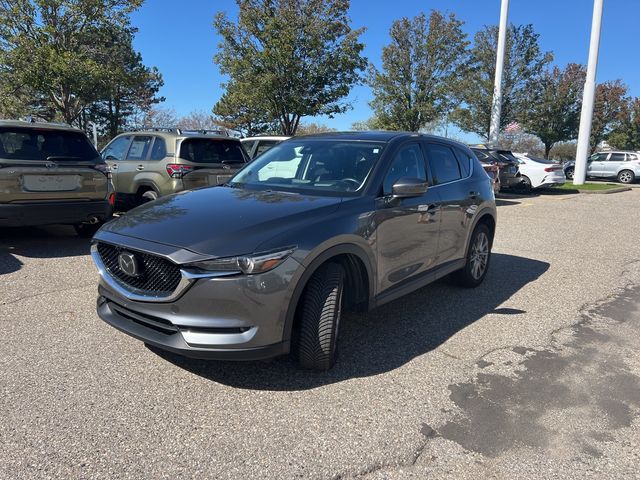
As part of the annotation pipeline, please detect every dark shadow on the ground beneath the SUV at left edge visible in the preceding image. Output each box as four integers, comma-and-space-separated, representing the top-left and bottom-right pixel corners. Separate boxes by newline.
0, 225, 90, 275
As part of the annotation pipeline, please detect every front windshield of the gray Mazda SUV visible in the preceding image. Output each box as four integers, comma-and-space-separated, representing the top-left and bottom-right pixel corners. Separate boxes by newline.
230, 139, 384, 193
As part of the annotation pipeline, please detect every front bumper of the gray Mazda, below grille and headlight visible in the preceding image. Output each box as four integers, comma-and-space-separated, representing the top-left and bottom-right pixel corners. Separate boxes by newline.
97, 249, 303, 360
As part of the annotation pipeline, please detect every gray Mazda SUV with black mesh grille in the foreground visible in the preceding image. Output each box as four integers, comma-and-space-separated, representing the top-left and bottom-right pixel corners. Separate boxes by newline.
92, 132, 496, 370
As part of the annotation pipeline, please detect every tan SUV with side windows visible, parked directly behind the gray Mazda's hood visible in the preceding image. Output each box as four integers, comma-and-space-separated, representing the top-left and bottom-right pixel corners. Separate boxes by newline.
102, 128, 249, 208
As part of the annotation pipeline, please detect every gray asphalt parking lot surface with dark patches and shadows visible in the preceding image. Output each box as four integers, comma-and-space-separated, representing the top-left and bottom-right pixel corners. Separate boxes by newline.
0, 189, 640, 479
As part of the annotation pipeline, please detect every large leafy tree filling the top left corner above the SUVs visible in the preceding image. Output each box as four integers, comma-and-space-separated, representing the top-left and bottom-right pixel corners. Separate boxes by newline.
0, 0, 142, 123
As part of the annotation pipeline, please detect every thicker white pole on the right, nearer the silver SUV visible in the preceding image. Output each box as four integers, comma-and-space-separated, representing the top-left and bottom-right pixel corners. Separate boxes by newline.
573, 0, 604, 185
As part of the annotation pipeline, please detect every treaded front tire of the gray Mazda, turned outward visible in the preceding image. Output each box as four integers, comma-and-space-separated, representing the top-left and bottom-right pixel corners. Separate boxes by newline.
298, 263, 344, 371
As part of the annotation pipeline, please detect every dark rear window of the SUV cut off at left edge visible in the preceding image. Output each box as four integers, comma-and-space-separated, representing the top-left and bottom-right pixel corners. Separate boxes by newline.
0, 127, 99, 162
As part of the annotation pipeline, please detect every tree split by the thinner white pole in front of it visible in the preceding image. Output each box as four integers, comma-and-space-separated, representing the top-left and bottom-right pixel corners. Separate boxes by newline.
452, 25, 553, 140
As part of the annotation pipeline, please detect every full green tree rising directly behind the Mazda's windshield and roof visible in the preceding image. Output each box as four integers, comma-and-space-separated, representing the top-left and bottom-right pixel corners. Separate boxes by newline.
214, 0, 366, 135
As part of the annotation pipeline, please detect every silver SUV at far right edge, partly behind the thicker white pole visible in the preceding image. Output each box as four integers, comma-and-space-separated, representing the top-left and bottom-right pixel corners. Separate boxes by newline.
564, 152, 640, 183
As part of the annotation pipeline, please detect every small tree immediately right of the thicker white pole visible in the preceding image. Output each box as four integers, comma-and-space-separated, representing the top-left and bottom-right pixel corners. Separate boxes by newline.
589, 80, 629, 153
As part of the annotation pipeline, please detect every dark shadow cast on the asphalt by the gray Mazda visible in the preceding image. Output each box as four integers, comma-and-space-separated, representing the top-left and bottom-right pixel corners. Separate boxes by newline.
149, 253, 549, 391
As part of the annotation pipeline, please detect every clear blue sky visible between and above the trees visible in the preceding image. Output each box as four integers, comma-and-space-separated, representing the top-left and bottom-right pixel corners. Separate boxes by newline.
133, 0, 640, 141
